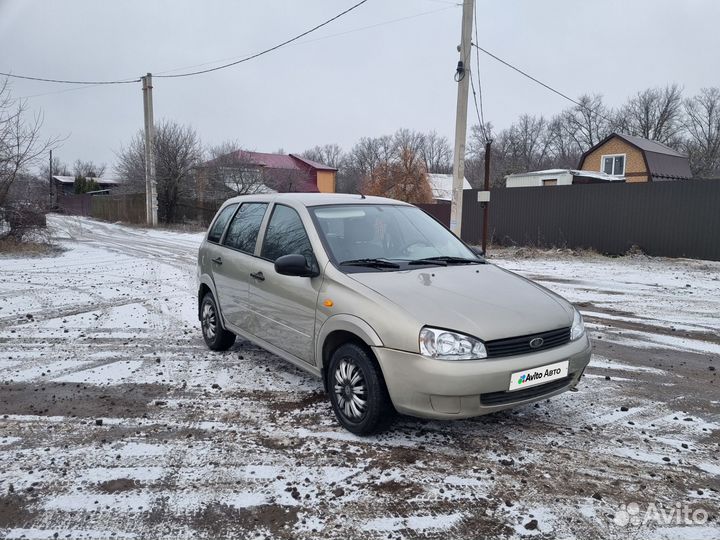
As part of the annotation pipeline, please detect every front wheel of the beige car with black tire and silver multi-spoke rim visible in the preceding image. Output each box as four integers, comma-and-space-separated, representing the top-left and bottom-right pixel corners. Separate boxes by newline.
327, 343, 395, 435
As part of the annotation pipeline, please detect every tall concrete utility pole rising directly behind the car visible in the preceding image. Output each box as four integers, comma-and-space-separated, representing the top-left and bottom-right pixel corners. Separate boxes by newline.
450, 0, 475, 237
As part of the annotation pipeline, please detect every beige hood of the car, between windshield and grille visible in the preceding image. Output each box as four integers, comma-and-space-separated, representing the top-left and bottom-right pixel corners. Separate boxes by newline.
350, 264, 573, 341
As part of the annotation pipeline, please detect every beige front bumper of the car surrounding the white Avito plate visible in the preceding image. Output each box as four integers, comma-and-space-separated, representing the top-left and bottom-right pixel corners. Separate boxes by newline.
373, 335, 591, 419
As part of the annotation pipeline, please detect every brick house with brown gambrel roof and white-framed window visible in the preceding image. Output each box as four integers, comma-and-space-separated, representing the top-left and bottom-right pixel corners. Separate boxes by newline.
578, 133, 692, 183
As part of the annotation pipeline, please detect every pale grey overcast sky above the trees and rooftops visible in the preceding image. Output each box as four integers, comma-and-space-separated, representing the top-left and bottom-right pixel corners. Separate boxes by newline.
0, 0, 720, 173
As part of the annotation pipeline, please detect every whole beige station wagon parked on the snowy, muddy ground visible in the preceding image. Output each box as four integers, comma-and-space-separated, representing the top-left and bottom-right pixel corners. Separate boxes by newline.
198, 193, 590, 435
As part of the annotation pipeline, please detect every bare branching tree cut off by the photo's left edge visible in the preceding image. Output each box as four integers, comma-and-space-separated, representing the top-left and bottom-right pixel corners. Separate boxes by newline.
0, 79, 58, 207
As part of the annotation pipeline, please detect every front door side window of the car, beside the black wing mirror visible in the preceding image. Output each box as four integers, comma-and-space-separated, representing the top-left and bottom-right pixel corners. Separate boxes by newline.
260, 204, 315, 266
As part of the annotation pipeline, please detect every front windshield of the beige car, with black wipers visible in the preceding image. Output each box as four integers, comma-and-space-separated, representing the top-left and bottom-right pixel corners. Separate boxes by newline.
310, 204, 482, 271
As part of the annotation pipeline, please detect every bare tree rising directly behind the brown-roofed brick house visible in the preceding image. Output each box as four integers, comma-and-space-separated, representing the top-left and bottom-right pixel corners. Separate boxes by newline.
618, 84, 683, 147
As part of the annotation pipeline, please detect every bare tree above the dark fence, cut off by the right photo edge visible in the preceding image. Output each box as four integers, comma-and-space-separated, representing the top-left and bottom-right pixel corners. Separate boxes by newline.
684, 87, 720, 177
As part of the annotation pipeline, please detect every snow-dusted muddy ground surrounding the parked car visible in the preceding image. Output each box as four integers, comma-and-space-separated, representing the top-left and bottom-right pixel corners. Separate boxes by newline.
0, 216, 720, 539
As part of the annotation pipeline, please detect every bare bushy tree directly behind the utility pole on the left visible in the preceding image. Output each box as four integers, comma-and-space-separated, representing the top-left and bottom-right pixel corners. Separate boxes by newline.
116, 120, 202, 223
